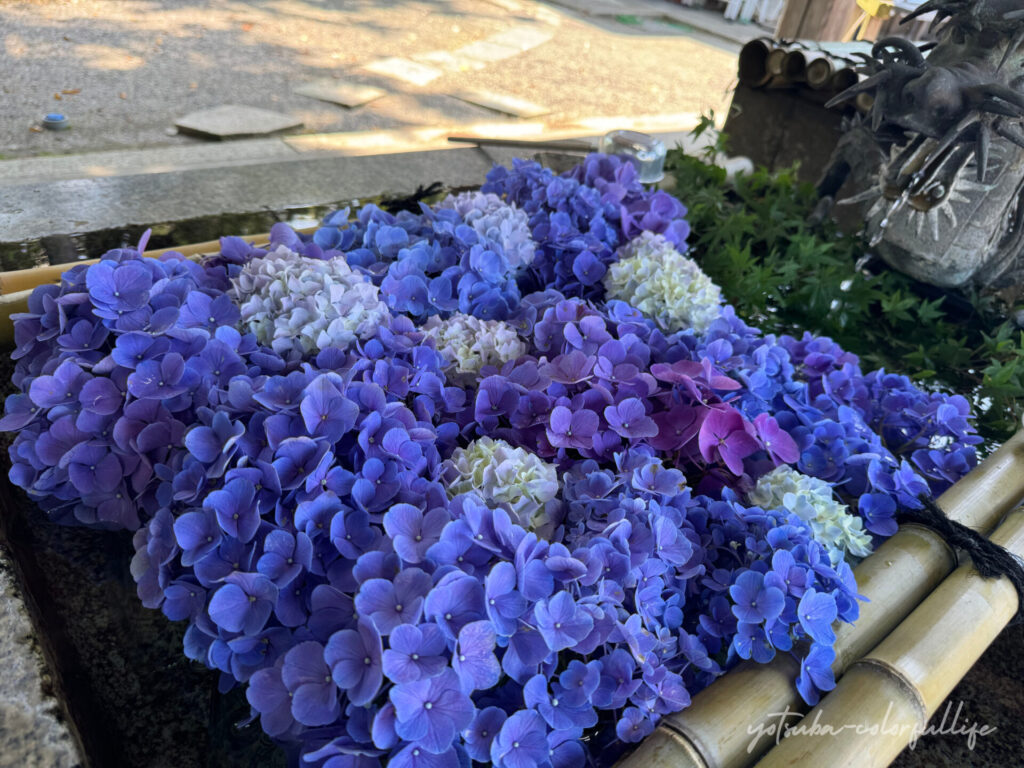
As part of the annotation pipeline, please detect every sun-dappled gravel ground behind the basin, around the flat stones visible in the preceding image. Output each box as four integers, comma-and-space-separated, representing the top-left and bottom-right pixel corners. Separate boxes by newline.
0, 0, 736, 157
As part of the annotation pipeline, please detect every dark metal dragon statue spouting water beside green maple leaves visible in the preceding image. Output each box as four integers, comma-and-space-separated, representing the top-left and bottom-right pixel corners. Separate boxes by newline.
830, 0, 1024, 290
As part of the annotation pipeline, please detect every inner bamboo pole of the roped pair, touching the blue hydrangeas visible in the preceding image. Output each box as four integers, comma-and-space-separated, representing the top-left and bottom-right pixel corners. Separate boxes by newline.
620, 431, 1024, 768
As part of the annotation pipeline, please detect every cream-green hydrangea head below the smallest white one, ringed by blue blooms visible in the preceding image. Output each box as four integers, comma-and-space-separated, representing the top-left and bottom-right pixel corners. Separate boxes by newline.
444, 437, 558, 531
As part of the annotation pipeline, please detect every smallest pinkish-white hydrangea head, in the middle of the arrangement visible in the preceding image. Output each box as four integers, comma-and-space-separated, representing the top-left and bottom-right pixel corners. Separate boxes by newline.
423, 313, 526, 374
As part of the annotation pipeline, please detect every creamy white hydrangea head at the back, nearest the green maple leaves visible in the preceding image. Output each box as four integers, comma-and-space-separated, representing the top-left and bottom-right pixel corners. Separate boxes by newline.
604, 232, 722, 333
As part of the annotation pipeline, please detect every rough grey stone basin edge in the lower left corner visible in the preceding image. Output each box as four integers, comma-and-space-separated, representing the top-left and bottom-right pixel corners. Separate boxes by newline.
0, 548, 84, 768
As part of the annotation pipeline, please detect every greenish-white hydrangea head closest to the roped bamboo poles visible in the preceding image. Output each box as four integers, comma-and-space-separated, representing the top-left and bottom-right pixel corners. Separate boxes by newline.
749, 466, 871, 565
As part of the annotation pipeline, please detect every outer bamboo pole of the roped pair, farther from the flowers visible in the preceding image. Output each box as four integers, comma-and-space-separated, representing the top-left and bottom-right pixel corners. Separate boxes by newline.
758, 510, 1024, 768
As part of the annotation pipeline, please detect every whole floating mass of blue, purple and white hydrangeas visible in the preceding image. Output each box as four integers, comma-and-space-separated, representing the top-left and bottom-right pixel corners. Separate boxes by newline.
0, 156, 979, 768
